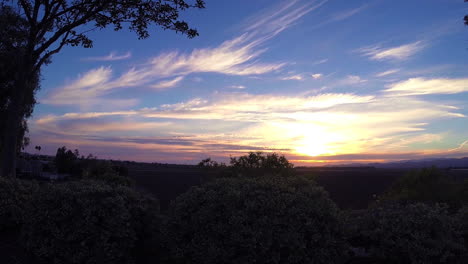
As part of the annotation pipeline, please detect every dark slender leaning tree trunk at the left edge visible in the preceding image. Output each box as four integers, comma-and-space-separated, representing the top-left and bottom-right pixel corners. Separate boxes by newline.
1, 67, 29, 177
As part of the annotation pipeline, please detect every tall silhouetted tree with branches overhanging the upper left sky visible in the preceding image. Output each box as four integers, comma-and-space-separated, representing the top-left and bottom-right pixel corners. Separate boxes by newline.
0, 0, 204, 177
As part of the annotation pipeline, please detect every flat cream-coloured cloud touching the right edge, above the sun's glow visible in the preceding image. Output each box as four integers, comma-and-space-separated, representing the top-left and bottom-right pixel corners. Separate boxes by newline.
385, 78, 468, 96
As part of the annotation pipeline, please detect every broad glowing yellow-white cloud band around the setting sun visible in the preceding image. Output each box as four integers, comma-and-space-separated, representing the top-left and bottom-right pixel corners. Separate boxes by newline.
31, 90, 464, 165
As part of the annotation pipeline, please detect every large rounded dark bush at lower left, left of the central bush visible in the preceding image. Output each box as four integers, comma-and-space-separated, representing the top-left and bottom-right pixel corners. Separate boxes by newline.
23, 181, 159, 263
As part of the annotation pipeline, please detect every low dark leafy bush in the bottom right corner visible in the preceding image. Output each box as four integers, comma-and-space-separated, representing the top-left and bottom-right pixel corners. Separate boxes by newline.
348, 203, 466, 263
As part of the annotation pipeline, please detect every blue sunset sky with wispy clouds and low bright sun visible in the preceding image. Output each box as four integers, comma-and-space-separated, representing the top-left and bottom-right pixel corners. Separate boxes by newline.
27, 0, 468, 166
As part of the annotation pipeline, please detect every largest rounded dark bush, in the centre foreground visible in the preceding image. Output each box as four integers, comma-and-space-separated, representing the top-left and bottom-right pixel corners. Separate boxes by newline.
166, 177, 345, 264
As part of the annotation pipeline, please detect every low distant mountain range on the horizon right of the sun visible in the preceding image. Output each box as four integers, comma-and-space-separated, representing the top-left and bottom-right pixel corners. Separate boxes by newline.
333, 157, 468, 169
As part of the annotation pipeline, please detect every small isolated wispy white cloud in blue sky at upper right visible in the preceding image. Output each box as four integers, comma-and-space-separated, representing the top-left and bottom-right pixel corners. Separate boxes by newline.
357, 41, 425, 60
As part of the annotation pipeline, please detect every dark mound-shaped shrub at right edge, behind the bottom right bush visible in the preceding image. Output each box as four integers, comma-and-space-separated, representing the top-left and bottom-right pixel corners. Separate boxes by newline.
380, 167, 468, 207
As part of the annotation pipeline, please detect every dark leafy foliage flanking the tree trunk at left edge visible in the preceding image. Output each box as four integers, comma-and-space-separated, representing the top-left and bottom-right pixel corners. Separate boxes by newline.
0, 6, 39, 157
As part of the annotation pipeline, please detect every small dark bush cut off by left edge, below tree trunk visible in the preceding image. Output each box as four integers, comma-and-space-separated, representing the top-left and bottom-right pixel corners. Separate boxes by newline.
0, 177, 39, 232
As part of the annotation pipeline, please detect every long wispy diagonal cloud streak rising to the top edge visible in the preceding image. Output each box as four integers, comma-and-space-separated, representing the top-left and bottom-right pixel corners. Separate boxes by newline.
41, 0, 327, 109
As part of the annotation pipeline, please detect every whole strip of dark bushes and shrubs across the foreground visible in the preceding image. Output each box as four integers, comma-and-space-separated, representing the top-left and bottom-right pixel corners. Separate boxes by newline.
0, 152, 468, 264
